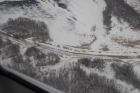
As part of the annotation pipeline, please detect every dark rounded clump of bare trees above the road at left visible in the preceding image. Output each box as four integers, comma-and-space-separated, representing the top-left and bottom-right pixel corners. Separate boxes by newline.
2, 17, 51, 42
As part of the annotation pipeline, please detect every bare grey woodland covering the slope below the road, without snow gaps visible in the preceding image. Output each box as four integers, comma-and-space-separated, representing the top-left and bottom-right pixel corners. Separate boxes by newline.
0, 37, 140, 93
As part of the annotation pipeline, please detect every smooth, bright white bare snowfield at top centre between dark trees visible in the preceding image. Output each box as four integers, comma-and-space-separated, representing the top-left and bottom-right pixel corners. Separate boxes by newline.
38, 0, 101, 46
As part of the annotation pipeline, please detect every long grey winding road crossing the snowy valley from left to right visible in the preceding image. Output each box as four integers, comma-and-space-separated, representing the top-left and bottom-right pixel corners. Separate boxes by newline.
0, 30, 140, 59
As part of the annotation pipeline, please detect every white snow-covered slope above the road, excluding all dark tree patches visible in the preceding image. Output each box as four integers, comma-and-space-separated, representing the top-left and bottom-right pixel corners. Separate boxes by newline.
0, 0, 140, 54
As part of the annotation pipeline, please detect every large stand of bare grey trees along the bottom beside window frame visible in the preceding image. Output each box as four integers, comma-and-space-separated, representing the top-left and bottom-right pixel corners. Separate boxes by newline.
9, 61, 123, 93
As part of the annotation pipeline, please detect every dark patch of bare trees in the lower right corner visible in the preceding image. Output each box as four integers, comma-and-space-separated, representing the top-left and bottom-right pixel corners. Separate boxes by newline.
111, 63, 140, 90
